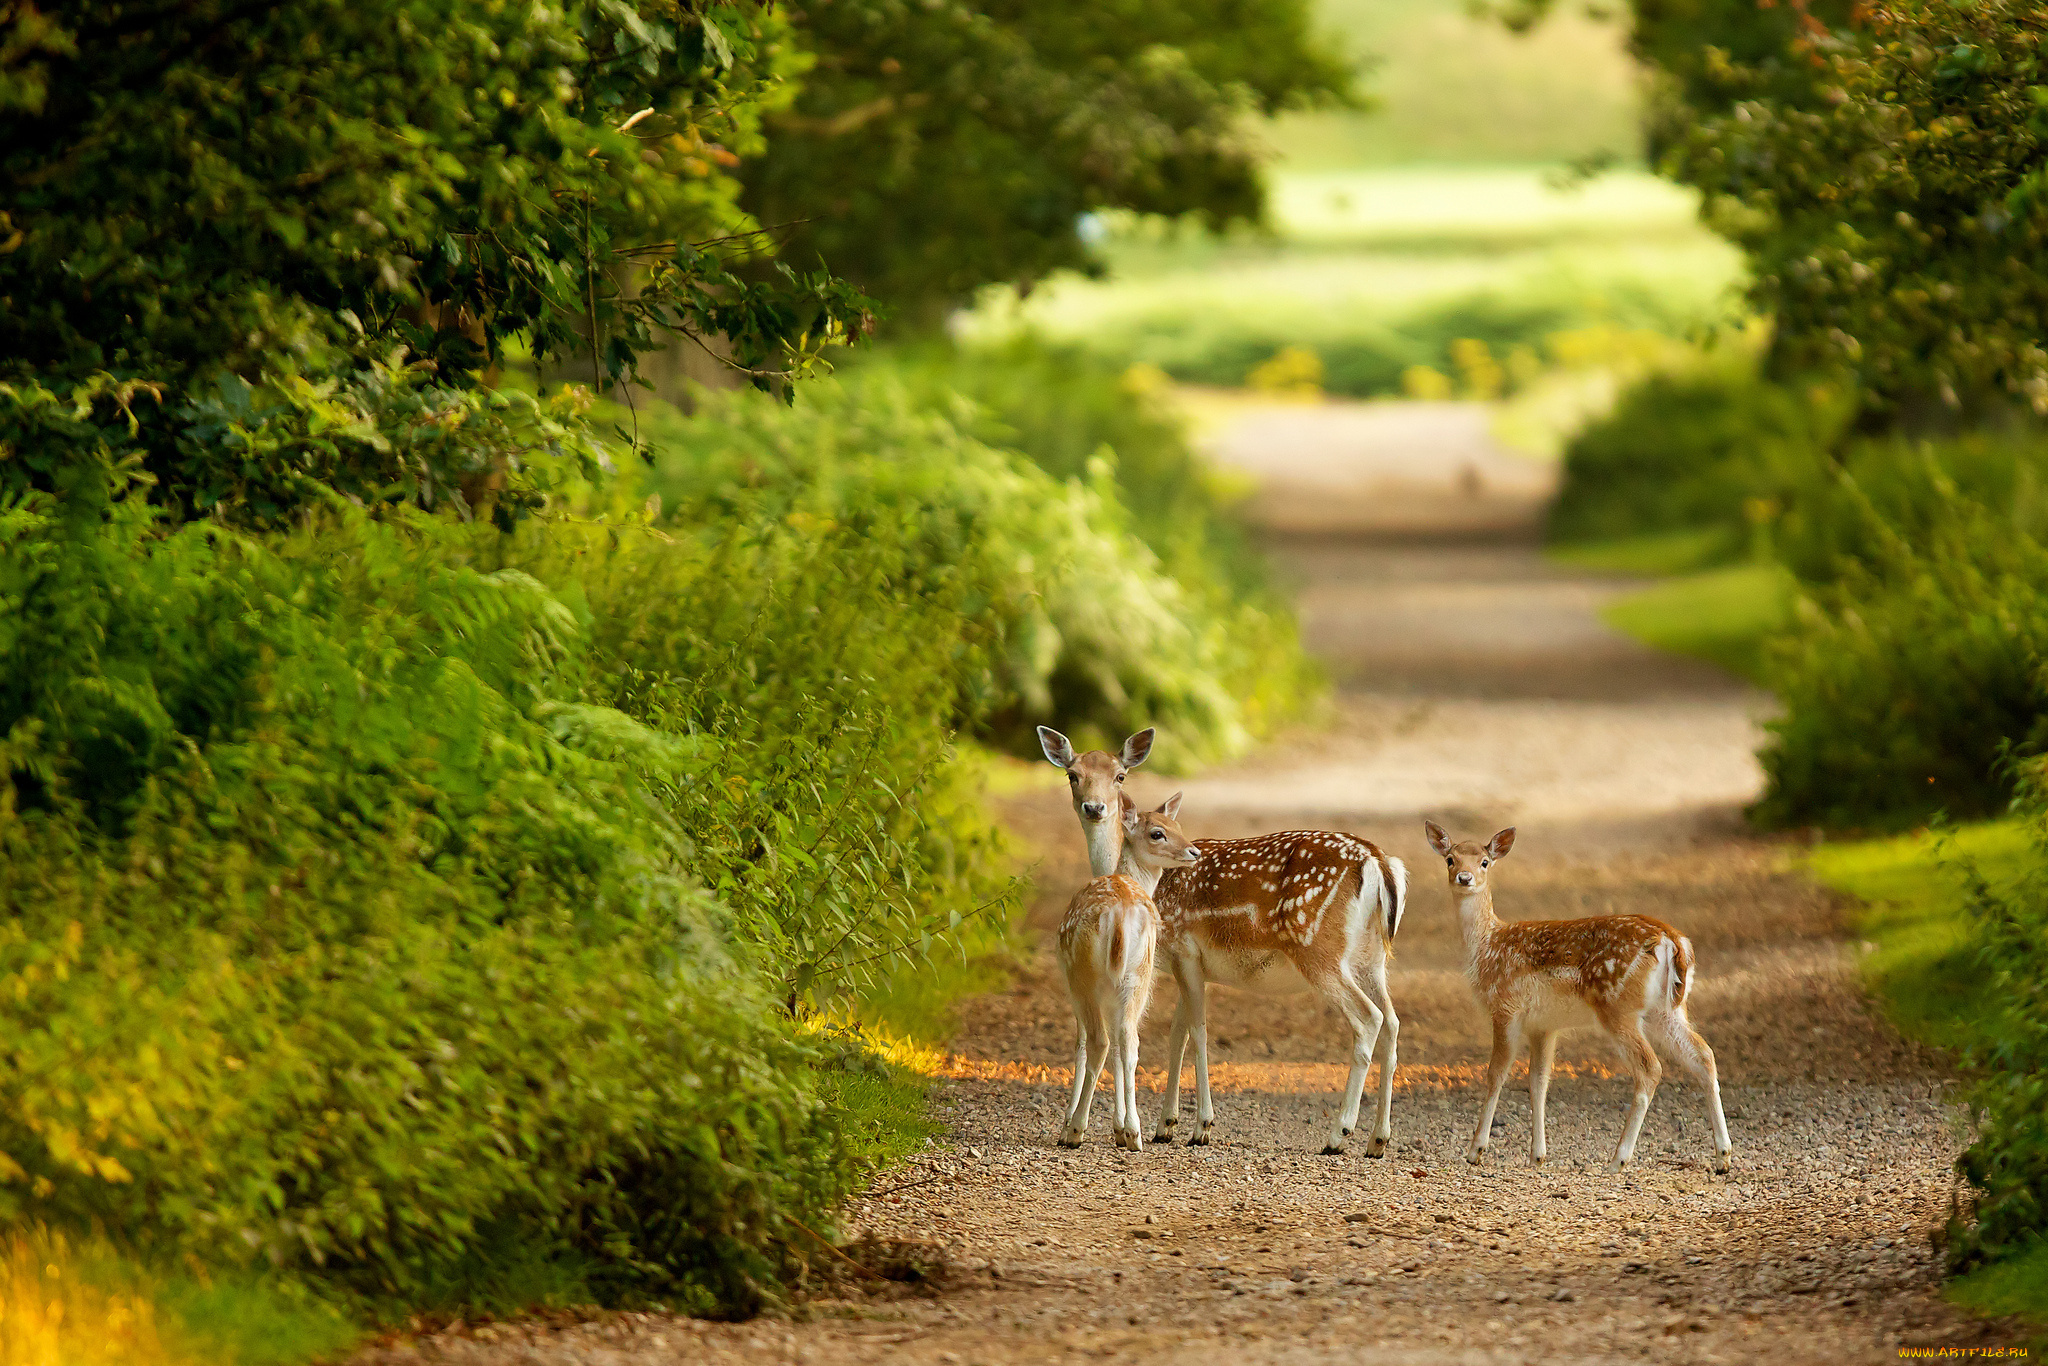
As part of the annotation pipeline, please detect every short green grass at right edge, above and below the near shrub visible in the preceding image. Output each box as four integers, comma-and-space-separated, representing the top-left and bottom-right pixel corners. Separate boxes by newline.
1804, 821, 2048, 1333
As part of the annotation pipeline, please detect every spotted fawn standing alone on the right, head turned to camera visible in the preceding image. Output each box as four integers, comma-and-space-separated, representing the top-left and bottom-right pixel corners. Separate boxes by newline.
1423, 821, 1731, 1171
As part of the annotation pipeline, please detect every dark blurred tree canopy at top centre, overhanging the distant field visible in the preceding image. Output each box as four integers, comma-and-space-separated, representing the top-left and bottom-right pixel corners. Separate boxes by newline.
741, 0, 1350, 322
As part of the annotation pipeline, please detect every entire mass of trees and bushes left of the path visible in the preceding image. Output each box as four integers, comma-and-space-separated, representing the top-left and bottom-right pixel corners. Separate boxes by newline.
0, 0, 1327, 1362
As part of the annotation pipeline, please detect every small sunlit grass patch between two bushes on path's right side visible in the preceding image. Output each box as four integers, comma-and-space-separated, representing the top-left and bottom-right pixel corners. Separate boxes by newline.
1602, 563, 1796, 682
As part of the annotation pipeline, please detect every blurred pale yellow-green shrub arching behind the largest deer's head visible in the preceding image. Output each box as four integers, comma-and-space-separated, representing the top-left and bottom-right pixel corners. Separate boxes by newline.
643, 369, 1303, 764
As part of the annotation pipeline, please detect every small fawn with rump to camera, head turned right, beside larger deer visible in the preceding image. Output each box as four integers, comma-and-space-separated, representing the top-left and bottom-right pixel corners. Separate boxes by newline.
1059, 793, 1200, 1153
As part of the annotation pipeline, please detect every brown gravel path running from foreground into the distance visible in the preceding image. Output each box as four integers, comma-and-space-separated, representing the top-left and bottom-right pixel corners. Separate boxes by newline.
364, 405, 1985, 1366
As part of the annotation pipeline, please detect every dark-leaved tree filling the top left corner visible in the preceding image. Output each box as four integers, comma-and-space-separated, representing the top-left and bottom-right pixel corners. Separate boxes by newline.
0, 0, 864, 520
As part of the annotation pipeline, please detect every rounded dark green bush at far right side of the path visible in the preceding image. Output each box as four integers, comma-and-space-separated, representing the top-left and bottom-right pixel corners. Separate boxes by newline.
1550, 356, 1847, 549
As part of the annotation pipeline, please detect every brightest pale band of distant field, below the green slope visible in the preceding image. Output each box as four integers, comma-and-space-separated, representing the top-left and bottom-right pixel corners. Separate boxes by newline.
963, 166, 1741, 395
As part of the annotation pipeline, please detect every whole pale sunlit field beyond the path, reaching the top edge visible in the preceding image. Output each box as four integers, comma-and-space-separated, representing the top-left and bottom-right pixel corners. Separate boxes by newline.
961, 0, 1741, 397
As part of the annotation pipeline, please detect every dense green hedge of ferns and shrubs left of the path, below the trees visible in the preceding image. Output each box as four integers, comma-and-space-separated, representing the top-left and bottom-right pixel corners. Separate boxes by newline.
0, 335, 1303, 1311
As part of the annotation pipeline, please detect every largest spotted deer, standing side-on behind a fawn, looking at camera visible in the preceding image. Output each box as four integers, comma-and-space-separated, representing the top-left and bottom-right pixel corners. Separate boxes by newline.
1038, 725, 1407, 1157
